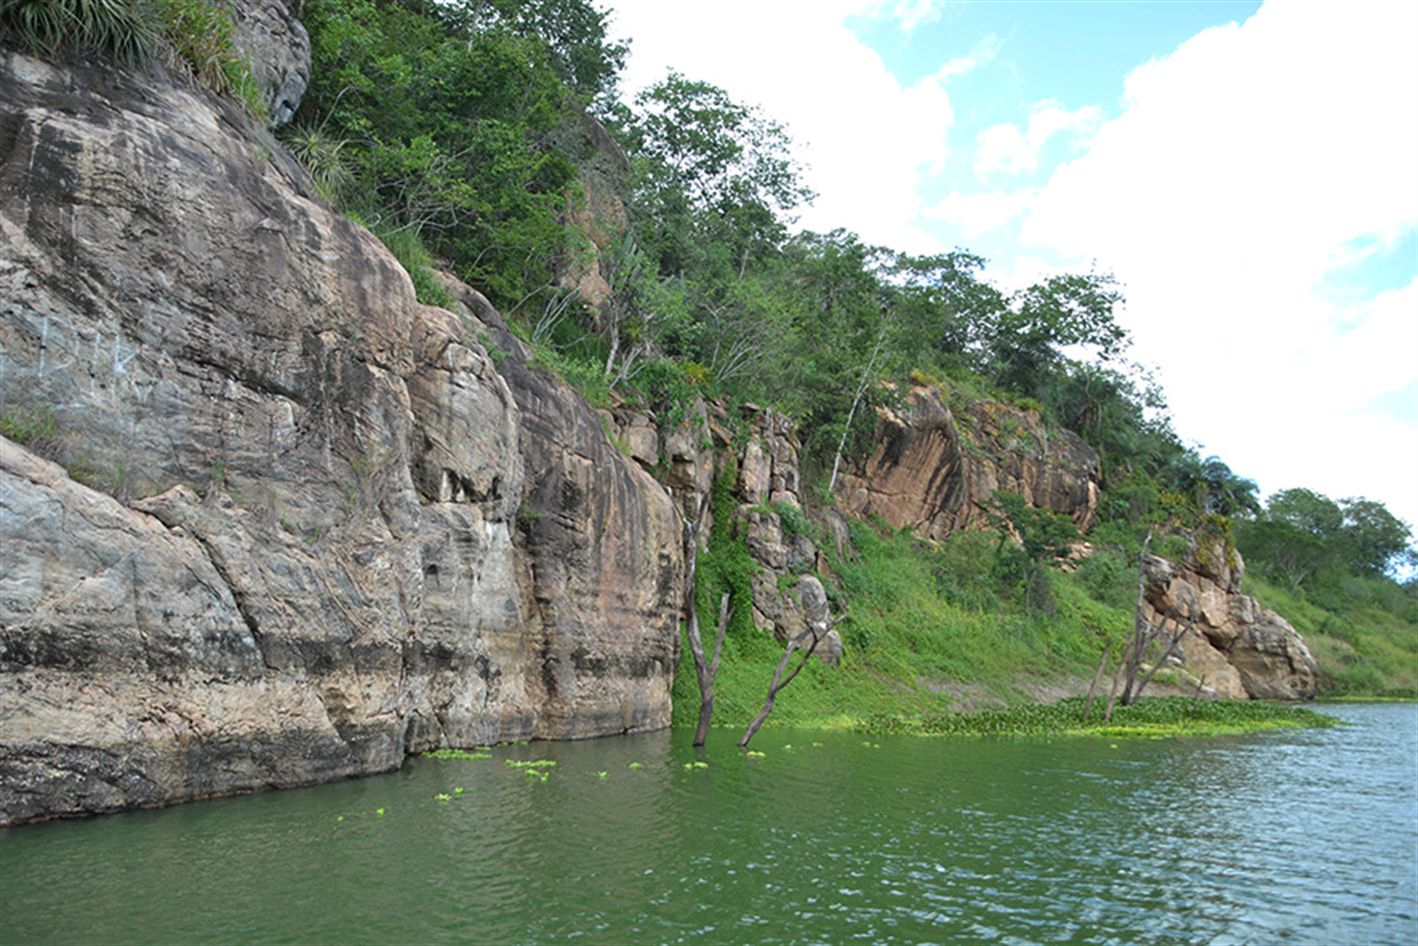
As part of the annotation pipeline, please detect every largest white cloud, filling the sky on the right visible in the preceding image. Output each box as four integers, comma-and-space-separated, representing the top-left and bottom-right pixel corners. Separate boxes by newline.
1021, 3, 1418, 523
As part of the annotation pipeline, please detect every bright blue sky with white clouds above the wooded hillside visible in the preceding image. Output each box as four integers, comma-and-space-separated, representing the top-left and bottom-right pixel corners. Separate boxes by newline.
604, 0, 1418, 536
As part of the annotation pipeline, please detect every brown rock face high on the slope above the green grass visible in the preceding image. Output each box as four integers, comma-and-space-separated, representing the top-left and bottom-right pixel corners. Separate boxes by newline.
837, 387, 1098, 539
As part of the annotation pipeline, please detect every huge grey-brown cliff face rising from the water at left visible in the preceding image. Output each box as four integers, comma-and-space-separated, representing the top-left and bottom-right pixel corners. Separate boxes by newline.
0, 52, 682, 823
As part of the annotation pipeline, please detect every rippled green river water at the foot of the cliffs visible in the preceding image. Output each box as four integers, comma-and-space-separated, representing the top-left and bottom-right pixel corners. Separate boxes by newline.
0, 706, 1418, 946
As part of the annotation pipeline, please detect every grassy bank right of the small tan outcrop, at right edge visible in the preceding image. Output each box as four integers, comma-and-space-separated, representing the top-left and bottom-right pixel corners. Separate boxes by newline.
1245, 572, 1418, 699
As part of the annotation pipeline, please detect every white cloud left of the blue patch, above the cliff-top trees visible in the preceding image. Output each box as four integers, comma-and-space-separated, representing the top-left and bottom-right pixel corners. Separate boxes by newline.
611, 0, 964, 251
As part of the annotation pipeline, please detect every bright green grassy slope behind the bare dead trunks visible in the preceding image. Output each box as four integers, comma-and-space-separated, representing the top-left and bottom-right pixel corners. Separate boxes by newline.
674, 523, 1132, 726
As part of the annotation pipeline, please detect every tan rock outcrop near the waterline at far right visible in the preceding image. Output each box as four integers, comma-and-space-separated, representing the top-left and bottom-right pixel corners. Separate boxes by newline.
1143, 539, 1317, 699
